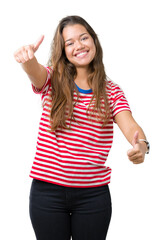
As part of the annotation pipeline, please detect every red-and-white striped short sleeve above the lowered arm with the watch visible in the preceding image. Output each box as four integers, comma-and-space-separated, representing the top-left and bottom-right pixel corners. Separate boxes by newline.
111, 82, 131, 121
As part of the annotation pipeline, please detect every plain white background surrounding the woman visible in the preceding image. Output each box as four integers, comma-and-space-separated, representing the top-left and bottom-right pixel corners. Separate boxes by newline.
0, 0, 163, 240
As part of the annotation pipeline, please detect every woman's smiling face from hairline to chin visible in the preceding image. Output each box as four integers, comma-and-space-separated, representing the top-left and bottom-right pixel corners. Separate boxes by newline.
62, 24, 96, 68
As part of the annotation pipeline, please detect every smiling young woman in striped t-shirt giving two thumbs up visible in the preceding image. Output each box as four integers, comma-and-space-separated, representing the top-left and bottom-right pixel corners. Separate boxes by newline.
14, 16, 149, 240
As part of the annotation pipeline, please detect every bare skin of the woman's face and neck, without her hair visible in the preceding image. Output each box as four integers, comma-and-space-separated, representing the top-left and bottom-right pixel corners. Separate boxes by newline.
62, 24, 96, 89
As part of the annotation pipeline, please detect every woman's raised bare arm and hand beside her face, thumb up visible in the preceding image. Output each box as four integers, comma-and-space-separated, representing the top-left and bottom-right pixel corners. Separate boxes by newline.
14, 36, 47, 89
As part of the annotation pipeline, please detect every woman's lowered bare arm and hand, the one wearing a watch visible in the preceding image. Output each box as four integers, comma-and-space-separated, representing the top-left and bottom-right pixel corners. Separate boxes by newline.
115, 111, 147, 164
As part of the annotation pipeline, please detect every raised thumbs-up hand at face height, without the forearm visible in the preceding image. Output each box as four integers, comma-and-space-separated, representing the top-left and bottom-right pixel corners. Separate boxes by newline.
14, 35, 44, 63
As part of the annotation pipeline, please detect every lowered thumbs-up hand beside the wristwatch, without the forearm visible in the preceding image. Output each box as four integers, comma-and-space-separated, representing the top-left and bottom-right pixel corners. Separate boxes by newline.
127, 131, 146, 164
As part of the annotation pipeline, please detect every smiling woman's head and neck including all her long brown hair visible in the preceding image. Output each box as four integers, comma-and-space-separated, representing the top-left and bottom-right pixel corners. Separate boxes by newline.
48, 16, 110, 130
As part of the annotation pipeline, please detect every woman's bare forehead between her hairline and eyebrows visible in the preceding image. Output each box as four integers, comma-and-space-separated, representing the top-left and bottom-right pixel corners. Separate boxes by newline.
62, 24, 88, 41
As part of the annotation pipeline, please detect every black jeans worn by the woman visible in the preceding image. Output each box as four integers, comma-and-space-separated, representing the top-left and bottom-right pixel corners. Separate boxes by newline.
30, 179, 112, 240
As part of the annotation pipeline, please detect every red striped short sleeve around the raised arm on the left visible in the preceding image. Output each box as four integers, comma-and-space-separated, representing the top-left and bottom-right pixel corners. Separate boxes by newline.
32, 66, 52, 95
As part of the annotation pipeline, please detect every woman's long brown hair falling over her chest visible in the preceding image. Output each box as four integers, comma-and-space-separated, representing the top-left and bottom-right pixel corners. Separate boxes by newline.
48, 16, 110, 131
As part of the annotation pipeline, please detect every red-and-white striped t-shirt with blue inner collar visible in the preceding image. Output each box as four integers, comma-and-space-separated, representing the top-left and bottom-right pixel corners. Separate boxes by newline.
30, 67, 130, 188
